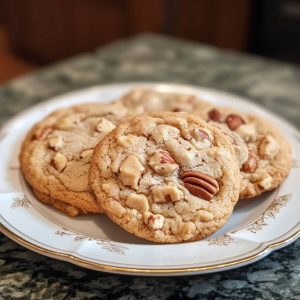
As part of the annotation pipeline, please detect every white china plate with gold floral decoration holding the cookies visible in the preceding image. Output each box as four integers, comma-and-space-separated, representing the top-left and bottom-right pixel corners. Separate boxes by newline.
0, 83, 300, 275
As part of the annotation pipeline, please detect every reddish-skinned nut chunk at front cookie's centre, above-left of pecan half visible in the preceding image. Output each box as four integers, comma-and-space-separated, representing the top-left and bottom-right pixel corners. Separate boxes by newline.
149, 150, 179, 176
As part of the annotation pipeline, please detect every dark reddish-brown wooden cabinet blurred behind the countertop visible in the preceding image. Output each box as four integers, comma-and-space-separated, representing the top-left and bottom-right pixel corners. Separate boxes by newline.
0, 0, 250, 63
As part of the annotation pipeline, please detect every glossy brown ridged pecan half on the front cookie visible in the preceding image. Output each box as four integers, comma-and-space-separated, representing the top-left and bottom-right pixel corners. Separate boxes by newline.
180, 171, 219, 201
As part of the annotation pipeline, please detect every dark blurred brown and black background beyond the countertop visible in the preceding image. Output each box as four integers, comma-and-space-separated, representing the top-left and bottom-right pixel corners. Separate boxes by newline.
0, 0, 300, 84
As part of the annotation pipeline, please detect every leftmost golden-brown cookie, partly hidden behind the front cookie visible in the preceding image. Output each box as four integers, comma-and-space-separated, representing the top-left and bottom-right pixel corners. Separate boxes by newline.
20, 104, 126, 216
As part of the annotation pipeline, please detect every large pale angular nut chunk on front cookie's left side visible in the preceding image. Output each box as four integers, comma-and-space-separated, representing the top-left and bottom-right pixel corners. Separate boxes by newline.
120, 155, 144, 189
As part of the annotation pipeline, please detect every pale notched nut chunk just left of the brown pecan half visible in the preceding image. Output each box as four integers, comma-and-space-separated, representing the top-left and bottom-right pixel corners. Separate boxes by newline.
152, 182, 183, 203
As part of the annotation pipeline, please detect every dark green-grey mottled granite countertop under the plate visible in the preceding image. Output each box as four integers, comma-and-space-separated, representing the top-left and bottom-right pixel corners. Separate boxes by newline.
0, 35, 300, 299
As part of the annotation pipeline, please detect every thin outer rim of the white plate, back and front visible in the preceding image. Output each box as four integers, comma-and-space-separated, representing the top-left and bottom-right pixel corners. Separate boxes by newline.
0, 81, 300, 276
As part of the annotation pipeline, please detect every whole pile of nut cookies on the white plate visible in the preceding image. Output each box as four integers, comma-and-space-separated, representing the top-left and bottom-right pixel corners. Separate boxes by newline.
20, 89, 291, 243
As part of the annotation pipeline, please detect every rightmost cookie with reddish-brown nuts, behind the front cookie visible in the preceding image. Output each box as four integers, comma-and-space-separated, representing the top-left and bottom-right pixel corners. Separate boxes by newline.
194, 105, 292, 198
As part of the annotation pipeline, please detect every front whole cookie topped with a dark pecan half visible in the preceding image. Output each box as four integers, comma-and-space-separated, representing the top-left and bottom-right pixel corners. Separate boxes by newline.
89, 112, 240, 243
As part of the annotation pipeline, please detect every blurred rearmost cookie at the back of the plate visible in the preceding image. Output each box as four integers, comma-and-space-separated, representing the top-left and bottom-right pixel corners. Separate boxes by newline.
118, 87, 209, 115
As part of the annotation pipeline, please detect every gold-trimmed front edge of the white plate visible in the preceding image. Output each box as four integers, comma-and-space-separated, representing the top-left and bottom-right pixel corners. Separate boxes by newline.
0, 224, 300, 275
